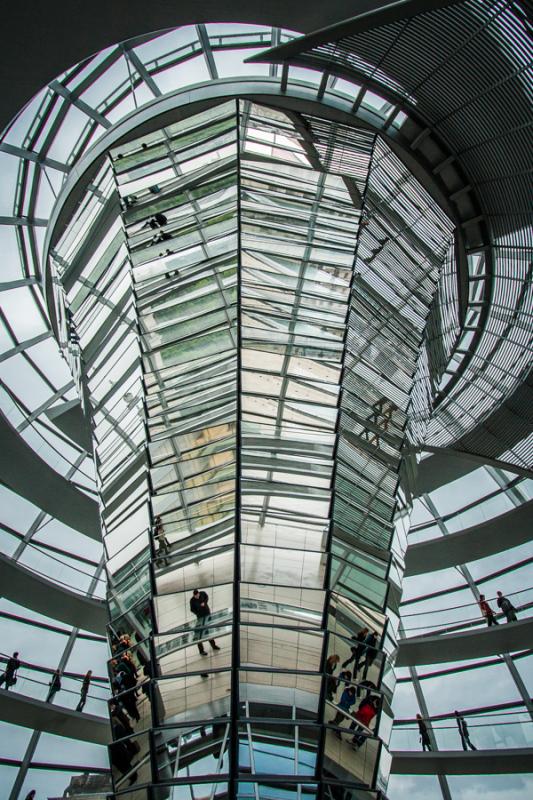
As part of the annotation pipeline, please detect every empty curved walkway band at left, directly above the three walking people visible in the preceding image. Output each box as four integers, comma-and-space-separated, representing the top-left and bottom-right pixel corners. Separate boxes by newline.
0, 554, 108, 634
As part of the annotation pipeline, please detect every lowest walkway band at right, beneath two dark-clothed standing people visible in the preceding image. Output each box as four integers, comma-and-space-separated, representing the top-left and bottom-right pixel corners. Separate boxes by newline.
391, 747, 533, 775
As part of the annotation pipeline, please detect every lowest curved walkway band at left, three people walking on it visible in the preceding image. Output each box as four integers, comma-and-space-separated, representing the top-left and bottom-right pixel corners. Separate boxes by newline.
0, 689, 111, 744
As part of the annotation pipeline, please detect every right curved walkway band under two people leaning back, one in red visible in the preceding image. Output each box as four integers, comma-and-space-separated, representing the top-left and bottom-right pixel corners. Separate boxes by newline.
396, 617, 533, 667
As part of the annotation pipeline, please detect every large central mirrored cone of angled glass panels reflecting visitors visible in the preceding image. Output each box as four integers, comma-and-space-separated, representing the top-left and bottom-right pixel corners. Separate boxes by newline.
48, 100, 453, 800
